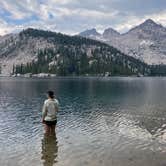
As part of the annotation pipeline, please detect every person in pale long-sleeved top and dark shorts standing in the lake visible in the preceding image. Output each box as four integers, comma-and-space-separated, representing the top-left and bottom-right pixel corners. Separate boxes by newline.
42, 91, 59, 135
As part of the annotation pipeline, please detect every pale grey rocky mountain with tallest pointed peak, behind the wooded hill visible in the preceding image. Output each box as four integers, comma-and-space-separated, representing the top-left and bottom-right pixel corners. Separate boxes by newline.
78, 19, 166, 65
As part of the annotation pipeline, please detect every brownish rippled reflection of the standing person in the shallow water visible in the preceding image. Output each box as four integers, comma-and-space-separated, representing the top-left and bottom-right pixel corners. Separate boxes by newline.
41, 133, 58, 166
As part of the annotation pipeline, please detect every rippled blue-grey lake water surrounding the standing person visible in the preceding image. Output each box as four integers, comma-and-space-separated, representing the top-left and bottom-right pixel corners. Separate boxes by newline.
0, 77, 166, 166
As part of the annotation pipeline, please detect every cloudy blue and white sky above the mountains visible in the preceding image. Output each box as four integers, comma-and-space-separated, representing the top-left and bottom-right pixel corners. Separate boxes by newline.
0, 0, 166, 35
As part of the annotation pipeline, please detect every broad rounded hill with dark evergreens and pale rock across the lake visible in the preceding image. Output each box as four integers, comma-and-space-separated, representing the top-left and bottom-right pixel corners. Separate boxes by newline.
0, 28, 150, 76
